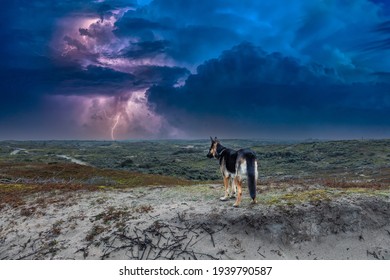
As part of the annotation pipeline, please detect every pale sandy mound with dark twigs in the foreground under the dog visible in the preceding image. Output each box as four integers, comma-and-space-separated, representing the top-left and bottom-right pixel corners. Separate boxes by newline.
0, 185, 390, 259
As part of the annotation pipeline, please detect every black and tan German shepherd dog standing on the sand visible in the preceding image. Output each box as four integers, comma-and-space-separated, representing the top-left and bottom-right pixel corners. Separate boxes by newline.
207, 137, 258, 207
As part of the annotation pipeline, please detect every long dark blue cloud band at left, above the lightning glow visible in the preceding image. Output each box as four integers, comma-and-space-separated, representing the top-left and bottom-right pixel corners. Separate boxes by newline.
0, 62, 136, 119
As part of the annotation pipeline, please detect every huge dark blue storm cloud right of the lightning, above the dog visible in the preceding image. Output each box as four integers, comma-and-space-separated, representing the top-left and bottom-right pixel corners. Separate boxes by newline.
148, 43, 390, 137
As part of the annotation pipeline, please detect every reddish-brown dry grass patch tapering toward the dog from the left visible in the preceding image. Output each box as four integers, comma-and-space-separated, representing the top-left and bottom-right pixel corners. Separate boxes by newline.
0, 162, 193, 210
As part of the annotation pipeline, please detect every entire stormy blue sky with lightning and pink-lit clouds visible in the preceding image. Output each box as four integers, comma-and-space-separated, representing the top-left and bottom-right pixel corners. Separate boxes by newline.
0, 0, 390, 140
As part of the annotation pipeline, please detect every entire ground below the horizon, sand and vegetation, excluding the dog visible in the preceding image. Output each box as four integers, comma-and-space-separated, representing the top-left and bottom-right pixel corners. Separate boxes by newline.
0, 140, 390, 259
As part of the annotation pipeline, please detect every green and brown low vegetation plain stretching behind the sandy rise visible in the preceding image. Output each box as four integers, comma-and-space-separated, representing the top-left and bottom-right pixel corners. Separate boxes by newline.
0, 140, 390, 209
